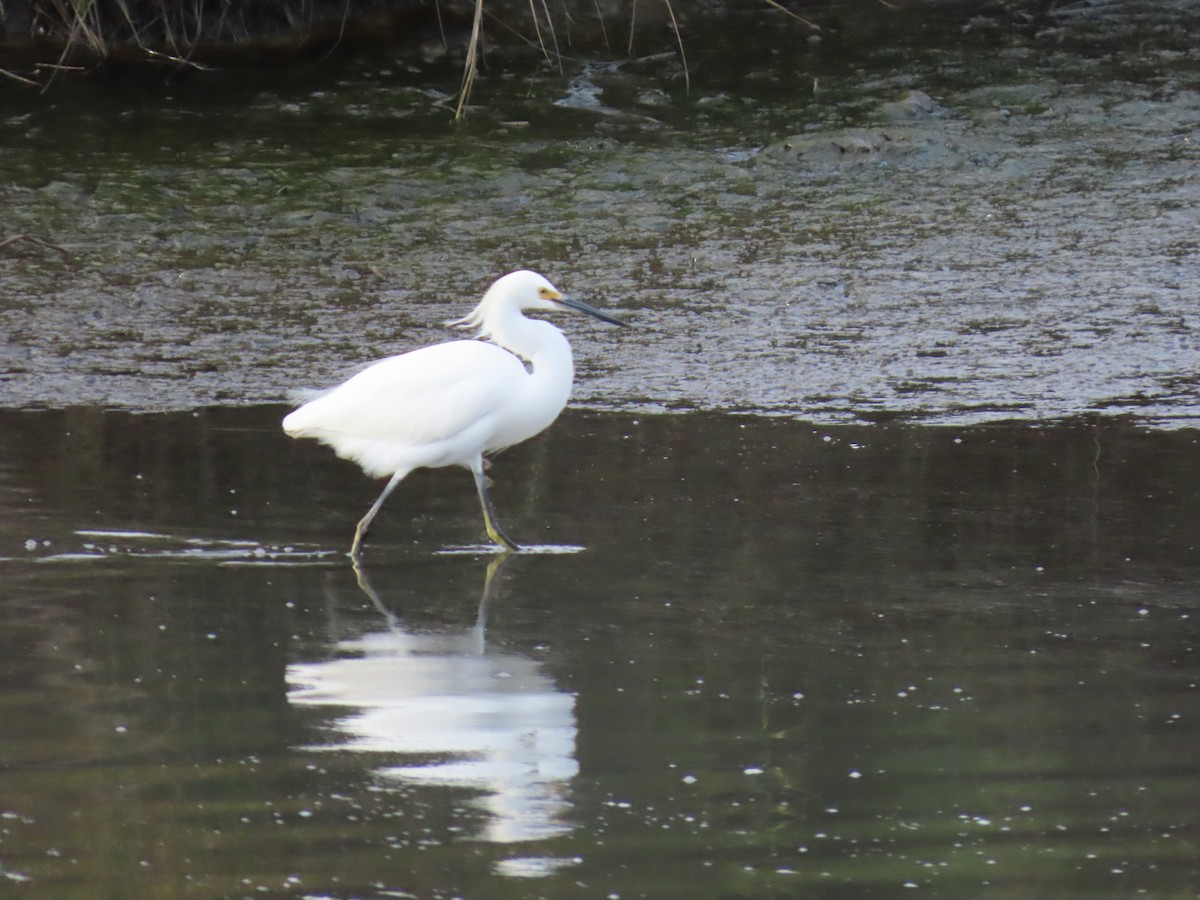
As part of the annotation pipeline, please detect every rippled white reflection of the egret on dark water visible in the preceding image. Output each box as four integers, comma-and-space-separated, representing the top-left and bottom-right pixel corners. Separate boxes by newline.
287, 554, 578, 844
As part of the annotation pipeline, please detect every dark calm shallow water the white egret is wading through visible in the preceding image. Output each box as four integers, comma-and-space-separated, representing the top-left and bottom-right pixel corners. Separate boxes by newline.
0, 407, 1200, 898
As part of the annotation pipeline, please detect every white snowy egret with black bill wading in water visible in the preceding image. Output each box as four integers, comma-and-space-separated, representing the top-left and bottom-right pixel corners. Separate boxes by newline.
283, 270, 628, 558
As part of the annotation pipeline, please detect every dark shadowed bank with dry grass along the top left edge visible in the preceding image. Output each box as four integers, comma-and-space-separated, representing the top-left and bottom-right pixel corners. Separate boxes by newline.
0, 0, 667, 80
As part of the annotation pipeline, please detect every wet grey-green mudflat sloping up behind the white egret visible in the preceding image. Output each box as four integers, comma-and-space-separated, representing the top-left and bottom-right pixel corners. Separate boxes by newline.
0, 7, 1200, 426
